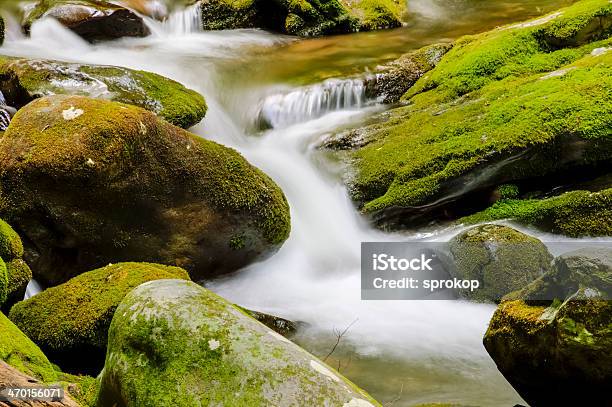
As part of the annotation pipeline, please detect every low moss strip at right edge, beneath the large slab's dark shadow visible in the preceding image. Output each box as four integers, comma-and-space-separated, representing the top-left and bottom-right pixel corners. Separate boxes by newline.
459, 189, 612, 237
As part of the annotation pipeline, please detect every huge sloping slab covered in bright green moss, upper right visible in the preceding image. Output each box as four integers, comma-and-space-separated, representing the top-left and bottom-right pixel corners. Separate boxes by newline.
349, 0, 612, 227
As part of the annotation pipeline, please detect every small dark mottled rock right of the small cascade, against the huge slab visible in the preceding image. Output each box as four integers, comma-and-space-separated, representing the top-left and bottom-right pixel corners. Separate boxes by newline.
367, 43, 452, 103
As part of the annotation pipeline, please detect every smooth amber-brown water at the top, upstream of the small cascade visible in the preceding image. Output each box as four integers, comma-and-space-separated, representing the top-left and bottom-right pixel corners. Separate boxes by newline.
225, 0, 574, 84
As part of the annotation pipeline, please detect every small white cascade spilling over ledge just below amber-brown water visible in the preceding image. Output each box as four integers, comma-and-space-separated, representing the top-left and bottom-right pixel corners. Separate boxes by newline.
259, 79, 375, 128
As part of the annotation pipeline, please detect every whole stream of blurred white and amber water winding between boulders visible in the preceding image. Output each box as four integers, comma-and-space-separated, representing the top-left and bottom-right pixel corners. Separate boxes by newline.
0, 0, 584, 406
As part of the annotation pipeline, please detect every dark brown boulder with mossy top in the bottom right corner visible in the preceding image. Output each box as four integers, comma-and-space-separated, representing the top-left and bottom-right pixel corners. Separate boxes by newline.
484, 247, 612, 407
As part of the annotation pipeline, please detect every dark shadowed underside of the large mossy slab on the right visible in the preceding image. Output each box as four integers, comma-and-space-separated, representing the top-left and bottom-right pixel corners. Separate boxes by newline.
371, 139, 612, 230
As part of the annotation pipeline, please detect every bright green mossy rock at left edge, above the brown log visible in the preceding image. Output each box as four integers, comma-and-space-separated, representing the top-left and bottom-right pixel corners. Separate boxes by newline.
0, 313, 57, 382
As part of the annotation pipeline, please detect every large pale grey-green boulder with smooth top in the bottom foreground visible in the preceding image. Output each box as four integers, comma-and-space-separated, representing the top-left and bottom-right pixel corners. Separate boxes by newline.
98, 280, 379, 407
